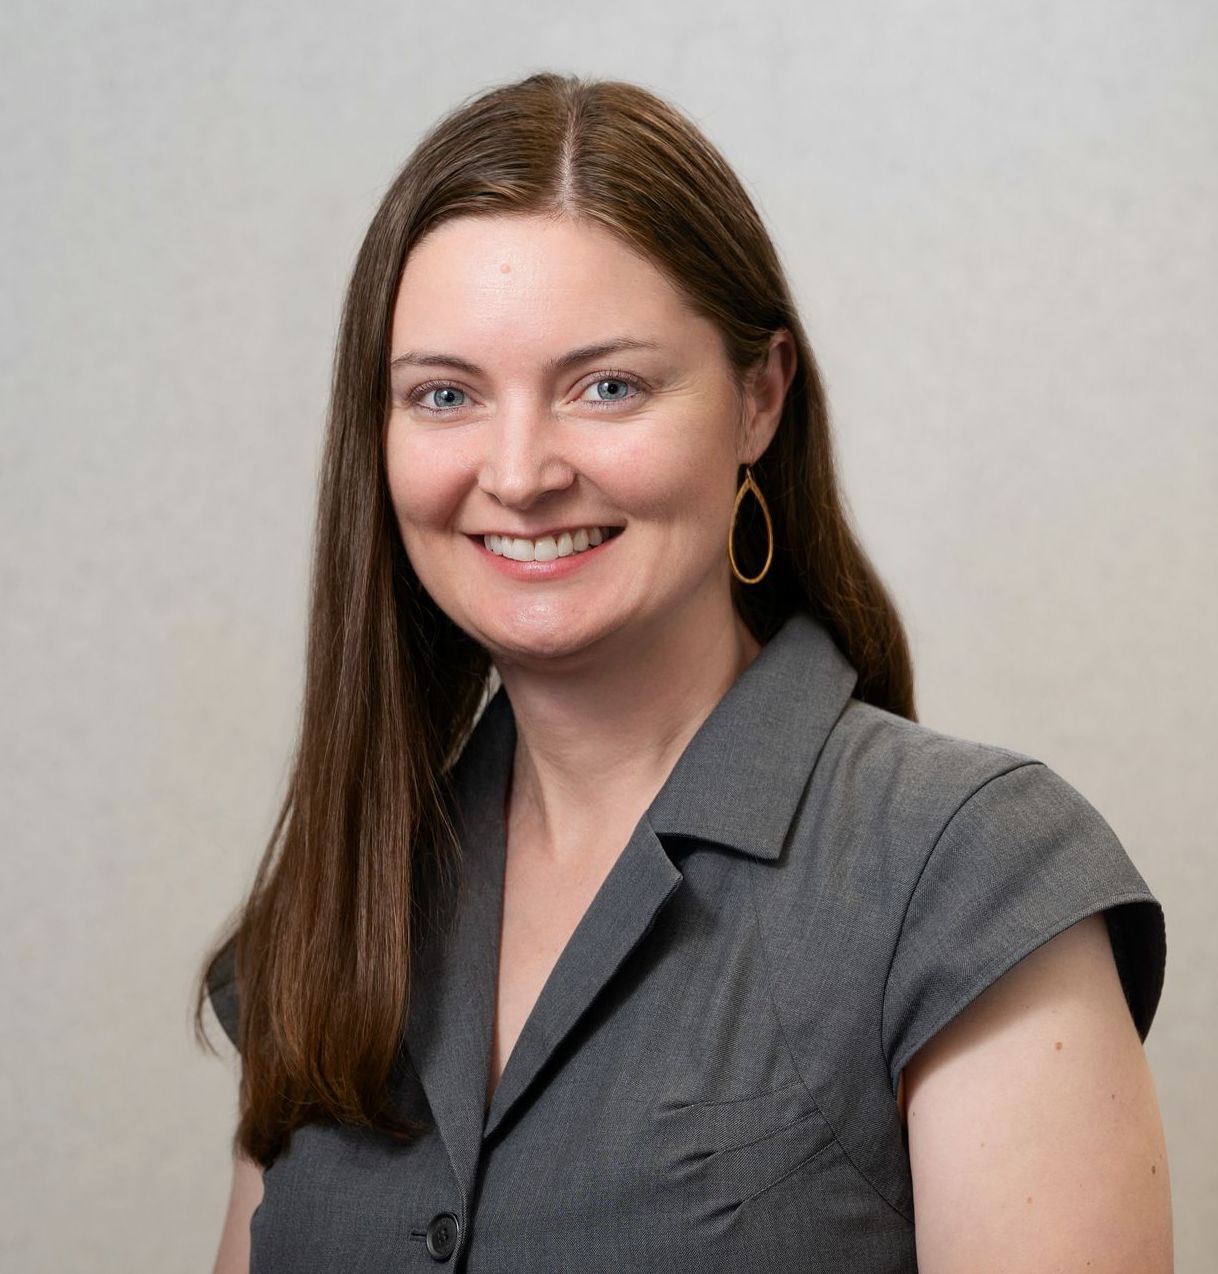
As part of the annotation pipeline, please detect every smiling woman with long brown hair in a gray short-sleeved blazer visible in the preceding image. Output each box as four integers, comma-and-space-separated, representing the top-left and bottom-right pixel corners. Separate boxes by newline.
197, 74, 1171, 1274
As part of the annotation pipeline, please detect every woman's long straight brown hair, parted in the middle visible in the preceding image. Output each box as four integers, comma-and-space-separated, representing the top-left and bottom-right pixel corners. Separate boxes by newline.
194, 73, 915, 1166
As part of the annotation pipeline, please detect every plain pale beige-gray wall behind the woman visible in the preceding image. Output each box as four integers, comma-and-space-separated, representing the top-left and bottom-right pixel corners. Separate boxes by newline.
0, 0, 1218, 1274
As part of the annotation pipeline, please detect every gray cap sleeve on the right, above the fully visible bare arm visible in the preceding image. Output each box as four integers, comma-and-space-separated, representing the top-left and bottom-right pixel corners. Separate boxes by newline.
882, 761, 1167, 1092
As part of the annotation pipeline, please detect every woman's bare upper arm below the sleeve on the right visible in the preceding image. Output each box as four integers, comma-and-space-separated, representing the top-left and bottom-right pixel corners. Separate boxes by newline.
902, 913, 1172, 1274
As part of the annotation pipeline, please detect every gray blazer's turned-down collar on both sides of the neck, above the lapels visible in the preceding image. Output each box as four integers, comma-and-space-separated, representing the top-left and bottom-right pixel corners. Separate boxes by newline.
448, 610, 859, 859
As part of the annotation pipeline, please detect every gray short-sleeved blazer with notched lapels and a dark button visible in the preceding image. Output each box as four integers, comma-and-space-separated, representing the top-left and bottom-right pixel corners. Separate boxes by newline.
211, 613, 1166, 1274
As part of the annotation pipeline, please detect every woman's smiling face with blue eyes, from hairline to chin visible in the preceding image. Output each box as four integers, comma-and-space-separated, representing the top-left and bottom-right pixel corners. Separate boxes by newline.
385, 215, 776, 662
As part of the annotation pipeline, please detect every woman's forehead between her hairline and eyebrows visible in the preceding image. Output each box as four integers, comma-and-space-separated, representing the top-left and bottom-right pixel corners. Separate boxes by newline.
392, 215, 716, 353
